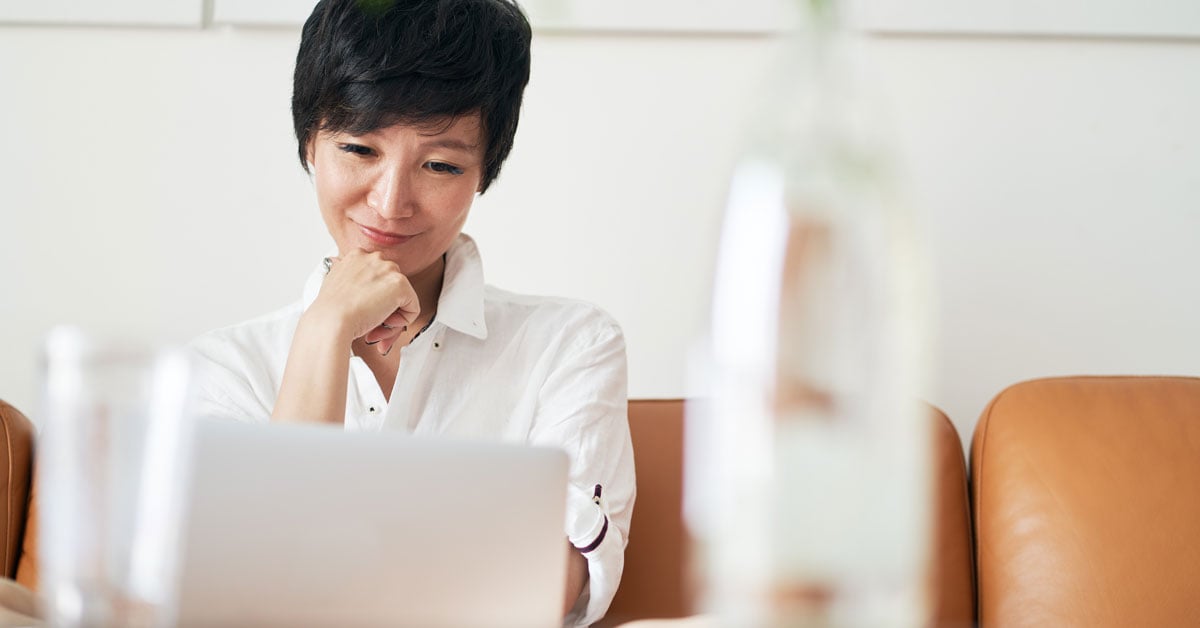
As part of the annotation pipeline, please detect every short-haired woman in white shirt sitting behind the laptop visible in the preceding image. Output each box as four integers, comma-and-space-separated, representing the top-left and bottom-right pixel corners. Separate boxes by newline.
193, 0, 634, 624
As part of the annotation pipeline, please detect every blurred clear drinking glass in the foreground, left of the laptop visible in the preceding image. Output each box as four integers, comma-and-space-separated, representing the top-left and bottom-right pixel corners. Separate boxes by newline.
37, 328, 192, 628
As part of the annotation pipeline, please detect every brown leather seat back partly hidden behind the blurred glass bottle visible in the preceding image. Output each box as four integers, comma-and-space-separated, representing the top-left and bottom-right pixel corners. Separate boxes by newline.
599, 400, 974, 626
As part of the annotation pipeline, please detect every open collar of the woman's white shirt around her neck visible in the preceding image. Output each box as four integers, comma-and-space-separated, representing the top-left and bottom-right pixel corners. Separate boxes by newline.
302, 233, 487, 340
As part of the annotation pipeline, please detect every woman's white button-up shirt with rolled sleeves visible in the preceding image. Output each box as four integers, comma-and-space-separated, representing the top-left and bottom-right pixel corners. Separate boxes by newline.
191, 235, 635, 626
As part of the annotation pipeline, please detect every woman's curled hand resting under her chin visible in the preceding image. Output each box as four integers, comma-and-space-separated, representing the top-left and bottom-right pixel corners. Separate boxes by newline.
305, 250, 421, 355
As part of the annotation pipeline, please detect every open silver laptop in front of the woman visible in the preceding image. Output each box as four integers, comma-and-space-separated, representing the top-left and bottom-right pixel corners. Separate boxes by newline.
179, 420, 568, 628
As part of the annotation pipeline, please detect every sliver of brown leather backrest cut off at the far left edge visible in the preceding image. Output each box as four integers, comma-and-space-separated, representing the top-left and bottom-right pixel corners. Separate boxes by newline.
0, 401, 34, 578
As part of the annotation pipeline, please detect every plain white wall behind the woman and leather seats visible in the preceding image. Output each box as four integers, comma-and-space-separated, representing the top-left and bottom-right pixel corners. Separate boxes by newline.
0, 26, 1200, 444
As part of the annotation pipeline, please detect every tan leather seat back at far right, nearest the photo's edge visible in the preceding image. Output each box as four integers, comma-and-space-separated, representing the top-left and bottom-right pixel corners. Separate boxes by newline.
971, 377, 1200, 627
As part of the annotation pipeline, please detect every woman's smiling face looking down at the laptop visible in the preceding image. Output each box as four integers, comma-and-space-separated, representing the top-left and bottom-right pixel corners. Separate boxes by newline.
308, 114, 484, 277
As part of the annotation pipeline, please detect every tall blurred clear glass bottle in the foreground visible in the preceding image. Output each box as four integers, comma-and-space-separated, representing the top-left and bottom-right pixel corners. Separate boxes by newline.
685, 0, 931, 627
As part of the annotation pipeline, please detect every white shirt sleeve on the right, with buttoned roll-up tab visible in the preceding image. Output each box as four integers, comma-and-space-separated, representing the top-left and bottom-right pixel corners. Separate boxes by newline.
530, 316, 636, 626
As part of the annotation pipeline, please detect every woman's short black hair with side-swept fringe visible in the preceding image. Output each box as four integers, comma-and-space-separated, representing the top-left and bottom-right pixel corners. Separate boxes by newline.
292, 0, 532, 191
